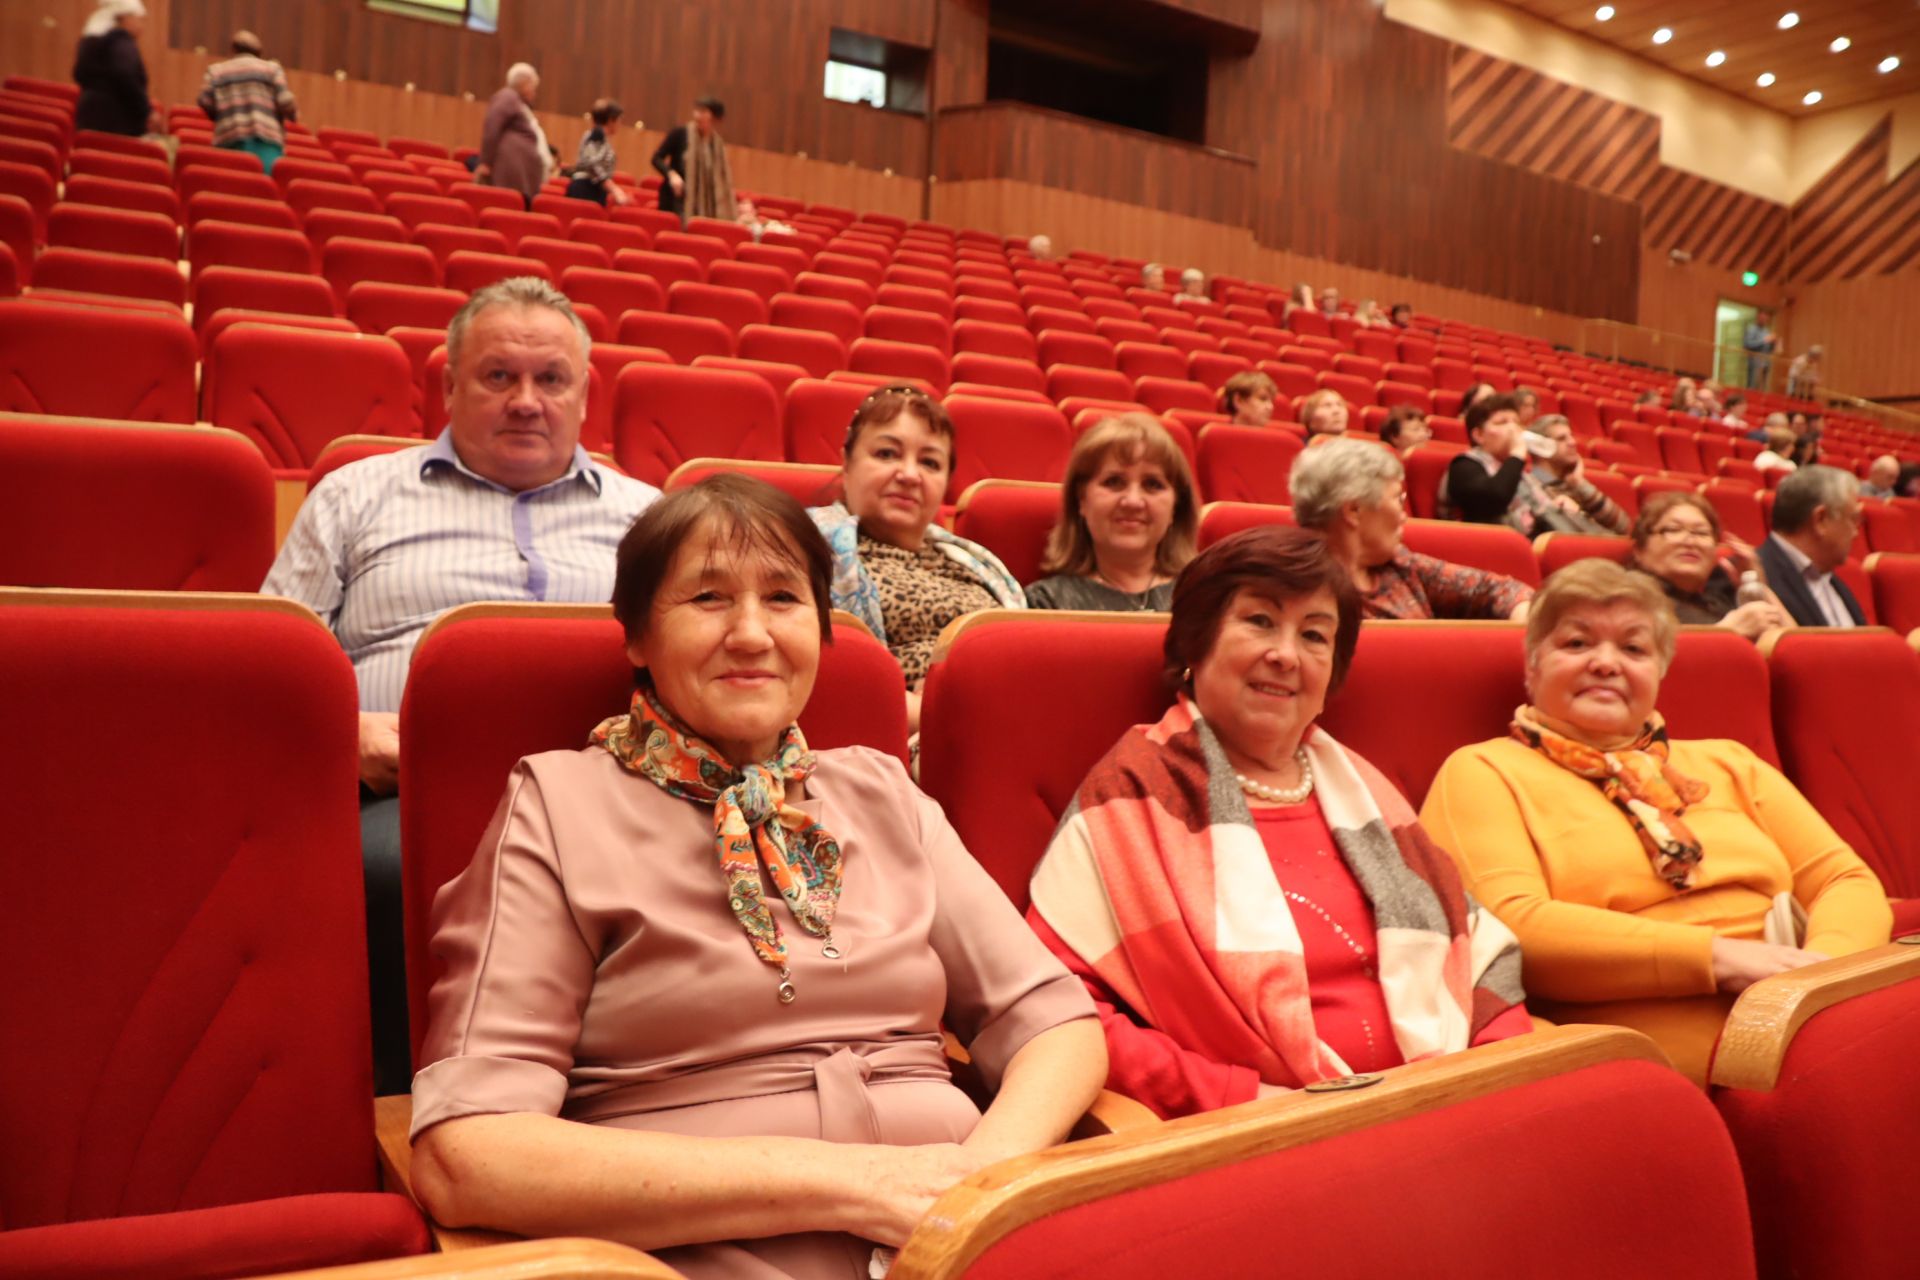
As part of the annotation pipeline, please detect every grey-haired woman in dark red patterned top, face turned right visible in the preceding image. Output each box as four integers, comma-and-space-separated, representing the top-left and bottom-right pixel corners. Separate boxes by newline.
1286, 439, 1534, 620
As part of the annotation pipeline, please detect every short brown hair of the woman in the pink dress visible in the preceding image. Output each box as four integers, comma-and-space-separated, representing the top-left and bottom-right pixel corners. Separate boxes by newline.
612, 472, 833, 643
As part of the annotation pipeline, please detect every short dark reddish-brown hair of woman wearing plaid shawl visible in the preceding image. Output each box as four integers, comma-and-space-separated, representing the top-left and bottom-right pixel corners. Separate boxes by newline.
1165, 524, 1359, 697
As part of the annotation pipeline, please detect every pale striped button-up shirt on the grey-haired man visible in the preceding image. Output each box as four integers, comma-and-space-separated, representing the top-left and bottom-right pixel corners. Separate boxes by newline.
261, 428, 660, 712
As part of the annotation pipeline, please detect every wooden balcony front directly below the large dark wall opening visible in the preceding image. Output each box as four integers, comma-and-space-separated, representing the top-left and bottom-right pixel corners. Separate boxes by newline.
935, 102, 1254, 226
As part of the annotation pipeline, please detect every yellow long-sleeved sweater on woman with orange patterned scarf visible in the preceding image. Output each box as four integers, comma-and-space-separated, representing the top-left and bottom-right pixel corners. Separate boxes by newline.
1421, 739, 1893, 1082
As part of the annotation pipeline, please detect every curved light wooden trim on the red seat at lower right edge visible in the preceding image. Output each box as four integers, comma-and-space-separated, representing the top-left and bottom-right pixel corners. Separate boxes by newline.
1709, 938, 1920, 1090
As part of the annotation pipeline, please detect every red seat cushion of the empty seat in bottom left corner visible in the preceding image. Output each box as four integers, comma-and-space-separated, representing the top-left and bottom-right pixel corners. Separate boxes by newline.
0, 1192, 428, 1280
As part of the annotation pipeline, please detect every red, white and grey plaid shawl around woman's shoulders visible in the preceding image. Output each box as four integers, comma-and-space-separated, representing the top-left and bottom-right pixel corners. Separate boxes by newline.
1033, 697, 1523, 1086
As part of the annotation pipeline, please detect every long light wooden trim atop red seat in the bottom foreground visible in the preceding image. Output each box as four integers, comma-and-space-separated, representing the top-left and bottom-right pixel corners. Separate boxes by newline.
889, 1027, 1668, 1280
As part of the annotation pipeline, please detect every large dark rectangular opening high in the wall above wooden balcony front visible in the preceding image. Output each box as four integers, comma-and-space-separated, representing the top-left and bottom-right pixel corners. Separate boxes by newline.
987, 0, 1210, 142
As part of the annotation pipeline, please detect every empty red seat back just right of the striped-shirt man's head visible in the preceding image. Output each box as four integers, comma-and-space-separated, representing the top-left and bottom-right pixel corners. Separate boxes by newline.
612, 362, 783, 486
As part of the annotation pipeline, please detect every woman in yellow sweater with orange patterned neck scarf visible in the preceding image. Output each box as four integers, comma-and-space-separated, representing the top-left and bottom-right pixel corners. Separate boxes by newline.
1421, 558, 1893, 1082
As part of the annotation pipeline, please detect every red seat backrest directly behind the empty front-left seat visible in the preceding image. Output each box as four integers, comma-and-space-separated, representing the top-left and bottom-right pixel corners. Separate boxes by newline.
0, 415, 273, 591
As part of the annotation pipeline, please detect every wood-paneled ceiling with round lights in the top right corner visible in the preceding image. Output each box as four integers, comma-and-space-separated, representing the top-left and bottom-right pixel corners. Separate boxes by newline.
1507, 0, 1920, 115
